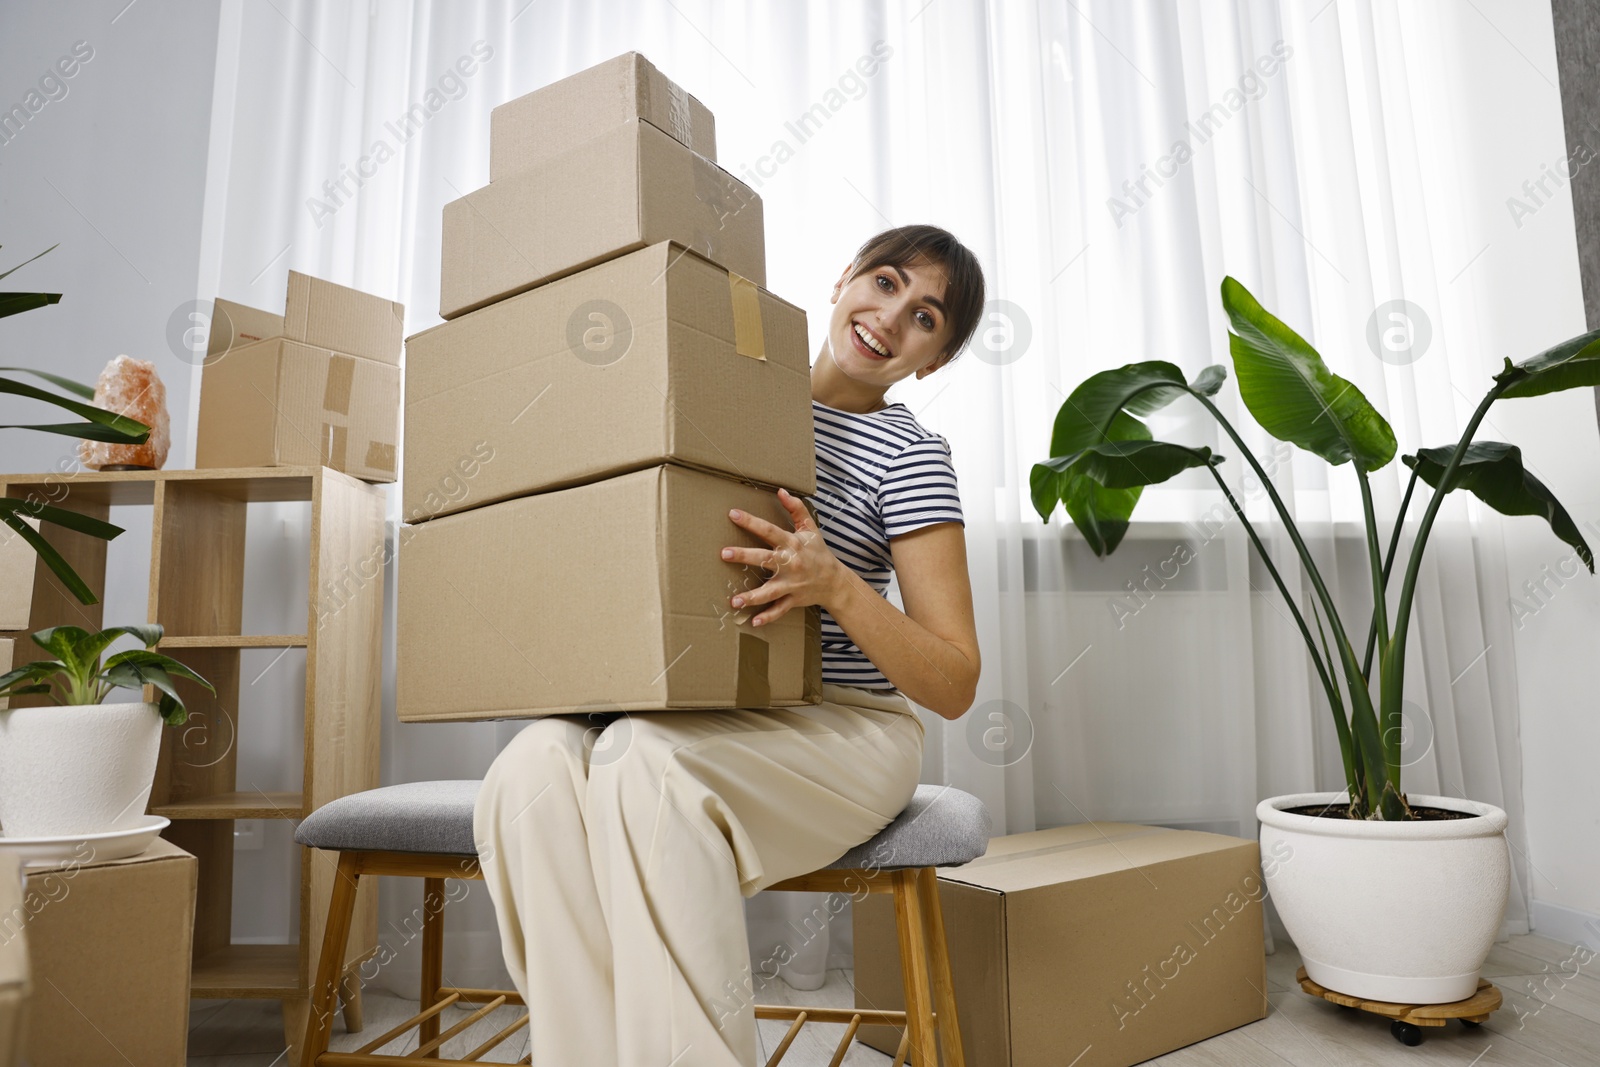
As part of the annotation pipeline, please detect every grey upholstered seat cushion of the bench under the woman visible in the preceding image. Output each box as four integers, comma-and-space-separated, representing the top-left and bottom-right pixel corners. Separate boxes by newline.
294, 781, 994, 870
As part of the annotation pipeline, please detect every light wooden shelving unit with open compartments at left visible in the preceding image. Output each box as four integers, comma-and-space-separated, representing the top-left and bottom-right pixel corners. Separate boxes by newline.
0, 467, 384, 1053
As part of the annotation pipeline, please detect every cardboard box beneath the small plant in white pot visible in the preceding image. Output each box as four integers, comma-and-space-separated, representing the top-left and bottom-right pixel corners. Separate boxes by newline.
26, 838, 198, 1067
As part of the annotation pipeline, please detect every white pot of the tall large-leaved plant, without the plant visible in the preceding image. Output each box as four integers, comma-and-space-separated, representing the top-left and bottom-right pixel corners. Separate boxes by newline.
1256, 793, 1510, 1005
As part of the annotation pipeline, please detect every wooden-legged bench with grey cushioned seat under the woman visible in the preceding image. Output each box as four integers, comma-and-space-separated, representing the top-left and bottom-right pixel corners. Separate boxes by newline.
294, 781, 992, 1067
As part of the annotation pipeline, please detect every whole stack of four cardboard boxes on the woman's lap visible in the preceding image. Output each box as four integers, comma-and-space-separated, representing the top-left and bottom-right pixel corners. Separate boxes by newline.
397, 53, 821, 721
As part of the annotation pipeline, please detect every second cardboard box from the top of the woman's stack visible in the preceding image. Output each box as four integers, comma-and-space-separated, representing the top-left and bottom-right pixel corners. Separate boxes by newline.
438, 120, 766, 318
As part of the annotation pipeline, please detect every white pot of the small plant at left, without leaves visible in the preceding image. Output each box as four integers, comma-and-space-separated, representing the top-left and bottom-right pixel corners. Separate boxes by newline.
0, 704, 163, 837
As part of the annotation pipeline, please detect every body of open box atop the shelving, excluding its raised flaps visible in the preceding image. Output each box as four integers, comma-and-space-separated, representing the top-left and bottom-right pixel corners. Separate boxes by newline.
195, 338, 400, 482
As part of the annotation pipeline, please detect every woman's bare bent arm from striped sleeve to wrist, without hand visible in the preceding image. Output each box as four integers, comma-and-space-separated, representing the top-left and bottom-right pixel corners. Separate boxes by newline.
822, 523, 979, 720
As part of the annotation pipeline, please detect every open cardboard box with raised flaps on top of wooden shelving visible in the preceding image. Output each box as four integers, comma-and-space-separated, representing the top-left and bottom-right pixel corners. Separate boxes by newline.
195, 270, 405, 482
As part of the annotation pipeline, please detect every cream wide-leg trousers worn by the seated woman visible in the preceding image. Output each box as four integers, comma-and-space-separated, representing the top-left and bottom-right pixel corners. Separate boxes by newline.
474, 685, 923, 1067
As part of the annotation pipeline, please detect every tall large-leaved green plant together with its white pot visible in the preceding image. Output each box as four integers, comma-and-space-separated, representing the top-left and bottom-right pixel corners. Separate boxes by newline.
1030, 278, 1600, 1003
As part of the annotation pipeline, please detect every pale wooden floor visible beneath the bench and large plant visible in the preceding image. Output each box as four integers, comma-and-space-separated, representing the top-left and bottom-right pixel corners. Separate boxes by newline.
189, 934, 1600, 1067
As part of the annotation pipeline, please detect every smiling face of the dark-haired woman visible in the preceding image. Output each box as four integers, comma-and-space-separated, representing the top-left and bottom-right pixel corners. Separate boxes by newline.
827, 254, 950, 389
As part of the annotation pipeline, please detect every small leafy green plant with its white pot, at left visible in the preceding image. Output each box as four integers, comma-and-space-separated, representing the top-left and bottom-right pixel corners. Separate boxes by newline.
0, 624, 216, 837
